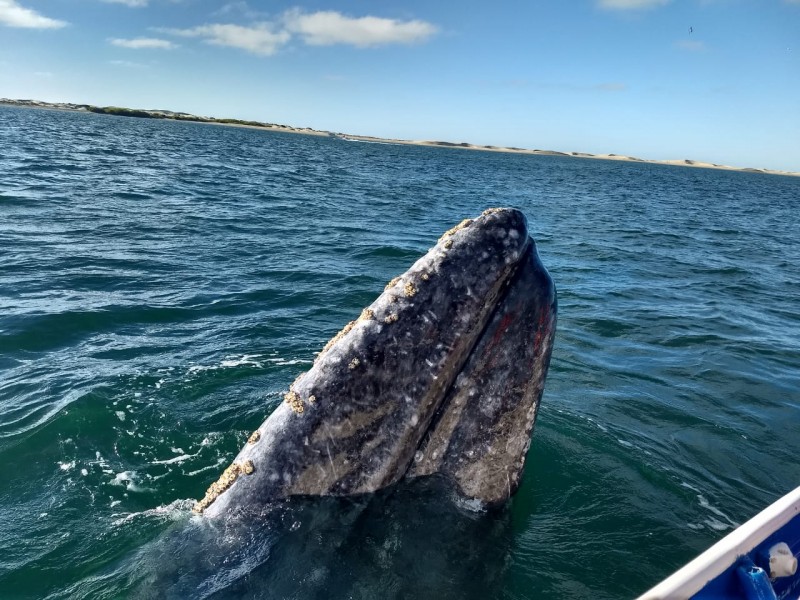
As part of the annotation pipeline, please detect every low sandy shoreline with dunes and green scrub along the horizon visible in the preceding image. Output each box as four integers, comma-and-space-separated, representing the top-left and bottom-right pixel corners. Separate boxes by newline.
0, 98, 800, 177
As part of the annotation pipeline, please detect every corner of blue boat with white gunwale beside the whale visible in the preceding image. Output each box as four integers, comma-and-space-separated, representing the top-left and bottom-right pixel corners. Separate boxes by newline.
639, 487, 800, 600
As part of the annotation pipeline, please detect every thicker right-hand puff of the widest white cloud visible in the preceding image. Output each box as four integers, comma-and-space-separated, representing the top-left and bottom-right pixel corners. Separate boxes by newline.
283, 9, 437, 48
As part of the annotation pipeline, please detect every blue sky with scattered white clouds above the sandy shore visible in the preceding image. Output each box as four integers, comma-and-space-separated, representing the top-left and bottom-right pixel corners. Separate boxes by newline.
0, 0, 800, 171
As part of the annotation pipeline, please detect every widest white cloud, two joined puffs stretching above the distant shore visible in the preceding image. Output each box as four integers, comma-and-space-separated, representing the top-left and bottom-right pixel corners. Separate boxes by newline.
160, 5, 438, 56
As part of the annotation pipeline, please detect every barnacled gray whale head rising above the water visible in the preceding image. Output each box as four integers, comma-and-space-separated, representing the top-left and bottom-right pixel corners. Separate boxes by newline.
204, 209, 556, 517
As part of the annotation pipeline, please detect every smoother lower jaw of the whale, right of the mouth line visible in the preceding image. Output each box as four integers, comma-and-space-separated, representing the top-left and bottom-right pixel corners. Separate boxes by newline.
406, 240, 556, 505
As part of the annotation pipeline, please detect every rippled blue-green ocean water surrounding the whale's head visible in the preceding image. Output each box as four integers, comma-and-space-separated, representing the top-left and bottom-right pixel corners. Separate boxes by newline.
0, 107, 800, 600
